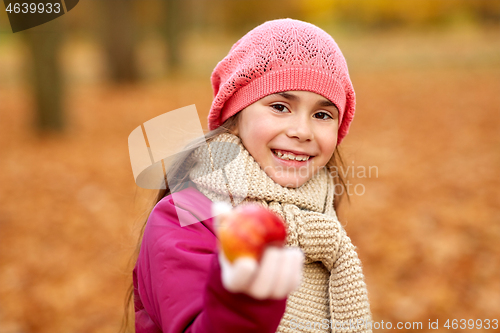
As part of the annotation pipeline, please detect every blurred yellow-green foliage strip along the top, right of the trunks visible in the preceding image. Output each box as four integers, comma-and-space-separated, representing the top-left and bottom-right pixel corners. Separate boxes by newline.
166, 0, 500, 34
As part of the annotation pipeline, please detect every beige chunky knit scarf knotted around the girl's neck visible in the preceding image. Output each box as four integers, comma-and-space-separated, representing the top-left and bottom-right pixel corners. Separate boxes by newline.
189, 133, 371, 333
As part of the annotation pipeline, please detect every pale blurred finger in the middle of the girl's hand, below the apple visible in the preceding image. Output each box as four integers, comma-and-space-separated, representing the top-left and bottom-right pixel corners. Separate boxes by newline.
249, 246, 280, 299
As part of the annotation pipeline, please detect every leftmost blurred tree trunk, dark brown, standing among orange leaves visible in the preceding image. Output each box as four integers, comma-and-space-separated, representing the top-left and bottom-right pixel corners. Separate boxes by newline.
24, 19, 66, 134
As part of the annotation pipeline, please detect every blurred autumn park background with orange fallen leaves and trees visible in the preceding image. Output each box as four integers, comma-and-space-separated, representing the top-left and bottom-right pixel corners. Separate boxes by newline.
0, 0, 500, 333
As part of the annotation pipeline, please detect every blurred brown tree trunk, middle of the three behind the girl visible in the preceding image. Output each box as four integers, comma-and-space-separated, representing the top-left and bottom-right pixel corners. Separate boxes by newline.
101, 0, 139, 83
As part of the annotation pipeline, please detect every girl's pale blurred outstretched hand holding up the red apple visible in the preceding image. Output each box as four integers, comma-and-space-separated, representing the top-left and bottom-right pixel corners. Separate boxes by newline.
219, 246, 304, 300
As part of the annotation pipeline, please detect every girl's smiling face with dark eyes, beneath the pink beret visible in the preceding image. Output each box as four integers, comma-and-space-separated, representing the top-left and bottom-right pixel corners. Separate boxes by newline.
233, 91, 339, 187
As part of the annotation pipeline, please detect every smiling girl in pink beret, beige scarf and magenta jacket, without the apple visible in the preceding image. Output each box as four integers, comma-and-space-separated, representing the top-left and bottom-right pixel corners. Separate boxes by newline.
129, 19, 371, 333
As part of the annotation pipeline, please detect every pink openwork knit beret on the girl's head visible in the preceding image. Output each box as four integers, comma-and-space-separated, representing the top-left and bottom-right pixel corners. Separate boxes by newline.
208, 19, 356, 144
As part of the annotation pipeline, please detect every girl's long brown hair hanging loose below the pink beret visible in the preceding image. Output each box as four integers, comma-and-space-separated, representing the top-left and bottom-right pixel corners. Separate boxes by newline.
120, 111, 350, 332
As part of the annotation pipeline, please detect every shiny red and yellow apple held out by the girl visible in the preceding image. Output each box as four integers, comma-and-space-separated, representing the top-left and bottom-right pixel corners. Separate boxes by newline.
218, 203, 286, 262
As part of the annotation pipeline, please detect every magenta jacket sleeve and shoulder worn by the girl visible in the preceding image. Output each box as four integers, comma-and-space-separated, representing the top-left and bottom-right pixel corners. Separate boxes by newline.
133, 186, 286, 333
